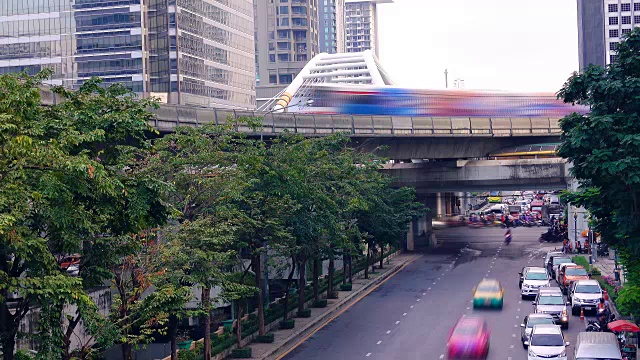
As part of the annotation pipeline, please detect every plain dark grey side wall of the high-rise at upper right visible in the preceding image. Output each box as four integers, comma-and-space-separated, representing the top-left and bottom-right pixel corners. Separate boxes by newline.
578, 0, 604, 70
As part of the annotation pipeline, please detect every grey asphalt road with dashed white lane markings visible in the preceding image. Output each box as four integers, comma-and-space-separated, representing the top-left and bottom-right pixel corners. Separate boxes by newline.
284, 227, 596, 360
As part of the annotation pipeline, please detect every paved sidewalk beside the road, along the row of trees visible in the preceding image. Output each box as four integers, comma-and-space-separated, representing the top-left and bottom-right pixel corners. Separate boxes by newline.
238, 254, 422, 360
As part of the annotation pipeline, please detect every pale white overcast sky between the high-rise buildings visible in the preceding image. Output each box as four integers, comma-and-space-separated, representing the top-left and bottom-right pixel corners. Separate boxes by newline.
378, 0, 578, 92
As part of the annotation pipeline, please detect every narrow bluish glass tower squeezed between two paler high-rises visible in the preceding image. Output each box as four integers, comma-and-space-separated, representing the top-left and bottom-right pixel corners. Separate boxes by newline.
318, 0, 346, 54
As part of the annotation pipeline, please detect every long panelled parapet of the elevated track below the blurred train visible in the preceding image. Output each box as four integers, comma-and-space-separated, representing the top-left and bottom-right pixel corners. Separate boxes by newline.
150, 105, 561, 137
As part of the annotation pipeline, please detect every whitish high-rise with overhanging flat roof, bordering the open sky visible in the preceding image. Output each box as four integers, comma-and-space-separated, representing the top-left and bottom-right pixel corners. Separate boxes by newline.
345, 0, 393, 57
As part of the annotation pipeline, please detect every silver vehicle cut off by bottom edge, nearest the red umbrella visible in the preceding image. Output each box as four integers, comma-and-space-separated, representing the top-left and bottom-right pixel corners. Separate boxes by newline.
573, 332, 622, 360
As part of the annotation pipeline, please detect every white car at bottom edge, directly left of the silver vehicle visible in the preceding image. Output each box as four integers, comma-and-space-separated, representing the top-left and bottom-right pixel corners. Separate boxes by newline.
524, 324, 569, 360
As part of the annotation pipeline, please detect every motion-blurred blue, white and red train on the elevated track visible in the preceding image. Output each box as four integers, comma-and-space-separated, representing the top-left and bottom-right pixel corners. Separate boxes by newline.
300, 84, 589, 118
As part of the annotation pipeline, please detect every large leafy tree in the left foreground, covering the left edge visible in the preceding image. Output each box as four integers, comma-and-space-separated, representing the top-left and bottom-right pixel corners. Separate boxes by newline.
0, 72, 166, 359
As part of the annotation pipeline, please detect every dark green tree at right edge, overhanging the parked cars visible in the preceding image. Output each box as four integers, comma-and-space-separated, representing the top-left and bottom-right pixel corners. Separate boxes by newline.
558, 29, 640, 313
